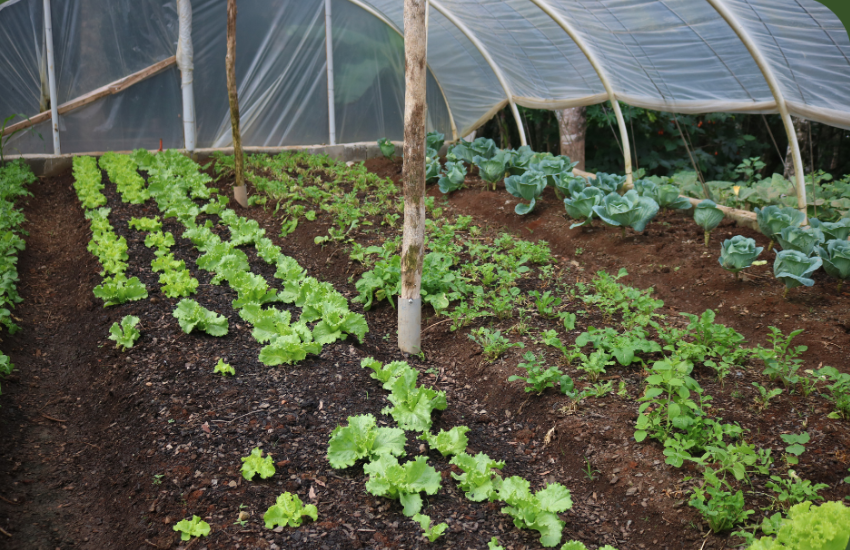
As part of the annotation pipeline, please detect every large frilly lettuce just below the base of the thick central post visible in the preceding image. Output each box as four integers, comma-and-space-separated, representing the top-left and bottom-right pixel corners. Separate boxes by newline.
381, 369, 447, 432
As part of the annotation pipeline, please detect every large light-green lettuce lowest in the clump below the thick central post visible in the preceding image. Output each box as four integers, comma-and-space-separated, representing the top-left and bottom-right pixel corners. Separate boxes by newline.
363, 454, 442, 517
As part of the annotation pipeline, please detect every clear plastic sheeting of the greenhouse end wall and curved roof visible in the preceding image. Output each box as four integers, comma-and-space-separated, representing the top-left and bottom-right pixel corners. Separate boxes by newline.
0, 0, 850, 157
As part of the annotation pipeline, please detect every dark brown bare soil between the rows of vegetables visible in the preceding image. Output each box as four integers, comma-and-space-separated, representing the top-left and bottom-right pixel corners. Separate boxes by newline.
0, 156, 850, 550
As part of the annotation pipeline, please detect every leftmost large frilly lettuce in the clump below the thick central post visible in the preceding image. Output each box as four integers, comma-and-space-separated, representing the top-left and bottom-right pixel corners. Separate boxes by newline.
328, 414, 406, 470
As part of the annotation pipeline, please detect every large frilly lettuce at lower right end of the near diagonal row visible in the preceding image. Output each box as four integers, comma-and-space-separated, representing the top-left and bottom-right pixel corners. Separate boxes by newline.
498, 476, 573, 548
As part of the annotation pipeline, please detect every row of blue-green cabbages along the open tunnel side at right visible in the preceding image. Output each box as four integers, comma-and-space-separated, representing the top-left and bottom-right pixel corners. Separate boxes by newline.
379, 133, 850, 294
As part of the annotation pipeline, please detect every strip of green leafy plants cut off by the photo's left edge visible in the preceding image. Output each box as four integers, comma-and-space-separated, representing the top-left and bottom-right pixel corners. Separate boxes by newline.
0, 161, 36, 402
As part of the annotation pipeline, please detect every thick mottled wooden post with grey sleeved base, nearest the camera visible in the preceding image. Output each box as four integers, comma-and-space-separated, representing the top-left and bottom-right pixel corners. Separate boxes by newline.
398, 0, 426, 353
